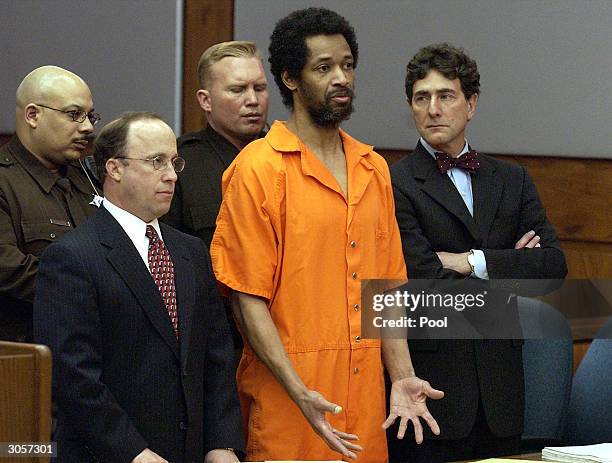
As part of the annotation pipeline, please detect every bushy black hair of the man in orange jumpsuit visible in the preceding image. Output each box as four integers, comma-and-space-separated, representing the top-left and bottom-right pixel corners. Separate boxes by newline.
268, 8, 359, 109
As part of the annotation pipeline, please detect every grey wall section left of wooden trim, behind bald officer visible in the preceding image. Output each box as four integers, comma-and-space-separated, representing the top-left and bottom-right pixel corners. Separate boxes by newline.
0, 0, 183, 133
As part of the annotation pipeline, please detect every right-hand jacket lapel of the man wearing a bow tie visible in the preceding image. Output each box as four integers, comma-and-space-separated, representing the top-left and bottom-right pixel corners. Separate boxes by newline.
472, 156, 504, 246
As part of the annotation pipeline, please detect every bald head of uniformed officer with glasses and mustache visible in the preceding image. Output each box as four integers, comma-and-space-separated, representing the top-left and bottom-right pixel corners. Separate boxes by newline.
15, 66, 94, 170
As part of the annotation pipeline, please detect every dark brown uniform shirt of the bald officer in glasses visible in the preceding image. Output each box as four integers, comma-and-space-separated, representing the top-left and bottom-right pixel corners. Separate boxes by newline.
0, 136, 96, 340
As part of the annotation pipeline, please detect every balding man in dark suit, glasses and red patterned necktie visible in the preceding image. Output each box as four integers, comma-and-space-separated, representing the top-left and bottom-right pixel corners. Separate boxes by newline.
34, 113, 243, 463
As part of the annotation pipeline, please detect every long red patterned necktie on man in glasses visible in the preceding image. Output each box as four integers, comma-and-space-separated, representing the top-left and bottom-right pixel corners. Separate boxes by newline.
145, 225, 178, 338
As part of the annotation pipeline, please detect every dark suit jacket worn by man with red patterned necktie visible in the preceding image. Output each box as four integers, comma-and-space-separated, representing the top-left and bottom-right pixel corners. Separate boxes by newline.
34, 207, 243, 463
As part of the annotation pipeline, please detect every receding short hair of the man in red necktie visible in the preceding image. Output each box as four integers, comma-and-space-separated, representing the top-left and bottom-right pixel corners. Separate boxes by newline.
93, 111, 163, 184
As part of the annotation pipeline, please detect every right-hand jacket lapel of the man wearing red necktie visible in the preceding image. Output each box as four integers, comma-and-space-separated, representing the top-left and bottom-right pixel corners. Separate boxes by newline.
160, 224, 195, 369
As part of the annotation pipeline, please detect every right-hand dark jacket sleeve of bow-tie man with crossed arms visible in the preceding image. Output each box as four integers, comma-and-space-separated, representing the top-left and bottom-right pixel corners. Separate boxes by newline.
482, 168, 567, 279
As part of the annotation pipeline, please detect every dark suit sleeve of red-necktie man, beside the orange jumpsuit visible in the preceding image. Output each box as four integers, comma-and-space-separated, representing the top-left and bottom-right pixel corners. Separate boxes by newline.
202, 241, 244, 454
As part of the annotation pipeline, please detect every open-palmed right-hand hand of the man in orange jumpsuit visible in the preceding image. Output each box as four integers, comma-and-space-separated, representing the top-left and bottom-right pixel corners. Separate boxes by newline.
383, 376, 444, 444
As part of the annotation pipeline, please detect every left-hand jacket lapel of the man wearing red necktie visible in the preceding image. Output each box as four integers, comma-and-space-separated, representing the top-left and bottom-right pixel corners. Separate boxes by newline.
96, 207, 180, 360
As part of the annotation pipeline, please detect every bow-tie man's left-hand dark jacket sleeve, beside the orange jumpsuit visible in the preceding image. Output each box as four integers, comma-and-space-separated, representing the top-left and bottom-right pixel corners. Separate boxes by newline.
393, 185, 465, 279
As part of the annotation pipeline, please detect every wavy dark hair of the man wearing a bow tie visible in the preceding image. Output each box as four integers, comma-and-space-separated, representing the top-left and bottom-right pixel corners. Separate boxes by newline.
406, 43, 480, 102
